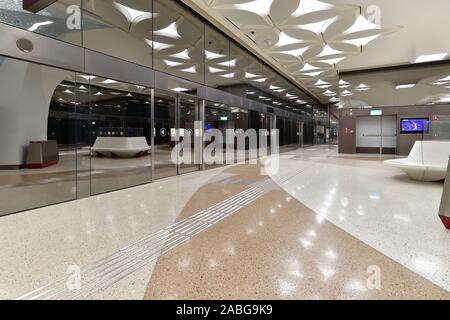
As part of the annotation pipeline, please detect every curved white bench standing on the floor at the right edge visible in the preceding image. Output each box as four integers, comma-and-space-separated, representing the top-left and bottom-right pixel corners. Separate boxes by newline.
384, 141, 450, 182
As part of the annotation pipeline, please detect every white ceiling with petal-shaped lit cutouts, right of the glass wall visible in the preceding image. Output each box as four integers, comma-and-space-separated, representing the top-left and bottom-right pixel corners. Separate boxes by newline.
183, 0, 450, 102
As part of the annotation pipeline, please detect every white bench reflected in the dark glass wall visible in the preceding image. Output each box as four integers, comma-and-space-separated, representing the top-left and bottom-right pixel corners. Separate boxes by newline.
91, 137, 150, 158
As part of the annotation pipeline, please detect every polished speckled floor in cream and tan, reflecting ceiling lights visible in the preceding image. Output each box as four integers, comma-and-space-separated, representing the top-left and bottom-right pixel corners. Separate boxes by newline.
0, 146, 450, 299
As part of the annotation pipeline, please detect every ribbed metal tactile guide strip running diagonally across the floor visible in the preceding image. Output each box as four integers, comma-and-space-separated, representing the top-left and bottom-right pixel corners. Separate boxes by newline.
18, 168, 307, 300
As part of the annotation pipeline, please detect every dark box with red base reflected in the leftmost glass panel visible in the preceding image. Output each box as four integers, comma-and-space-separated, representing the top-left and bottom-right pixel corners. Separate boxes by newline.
26, 140, 59, 169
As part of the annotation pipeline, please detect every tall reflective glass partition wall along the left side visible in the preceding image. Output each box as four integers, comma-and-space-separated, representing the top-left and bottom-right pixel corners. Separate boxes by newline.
0, 0, 313, 215
